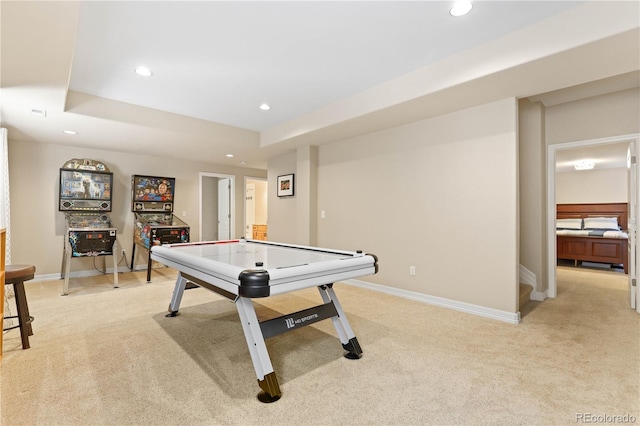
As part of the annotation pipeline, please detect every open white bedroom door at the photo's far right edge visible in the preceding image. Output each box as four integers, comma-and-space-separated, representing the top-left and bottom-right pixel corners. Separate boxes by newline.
627, 141, 640, 312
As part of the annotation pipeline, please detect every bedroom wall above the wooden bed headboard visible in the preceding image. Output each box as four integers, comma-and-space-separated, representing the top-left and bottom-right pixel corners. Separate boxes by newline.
556, 169, 628, 204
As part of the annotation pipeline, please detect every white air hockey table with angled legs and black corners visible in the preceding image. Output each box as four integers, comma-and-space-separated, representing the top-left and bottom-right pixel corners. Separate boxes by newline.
151, 239, 378, 402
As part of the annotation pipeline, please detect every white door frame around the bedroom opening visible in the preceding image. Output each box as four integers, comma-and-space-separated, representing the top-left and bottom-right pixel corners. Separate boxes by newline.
546, 133, 640, 299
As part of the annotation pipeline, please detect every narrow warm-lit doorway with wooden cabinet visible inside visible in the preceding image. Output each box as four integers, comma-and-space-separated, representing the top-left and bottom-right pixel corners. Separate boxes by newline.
244, 177, 268, 240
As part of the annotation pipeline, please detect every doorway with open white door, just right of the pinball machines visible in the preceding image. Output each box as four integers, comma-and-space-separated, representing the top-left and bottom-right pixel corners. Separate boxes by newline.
199, 172, 235, 241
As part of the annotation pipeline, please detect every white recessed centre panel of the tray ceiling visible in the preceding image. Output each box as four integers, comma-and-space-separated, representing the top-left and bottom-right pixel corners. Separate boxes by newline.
69, 1, 575, 131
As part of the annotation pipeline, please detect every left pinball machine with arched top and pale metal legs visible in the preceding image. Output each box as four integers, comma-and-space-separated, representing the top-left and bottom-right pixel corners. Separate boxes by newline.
58, 158, 118, 296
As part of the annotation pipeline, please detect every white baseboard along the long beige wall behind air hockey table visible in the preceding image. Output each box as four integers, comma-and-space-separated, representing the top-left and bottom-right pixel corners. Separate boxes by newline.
344, 280, 521, 324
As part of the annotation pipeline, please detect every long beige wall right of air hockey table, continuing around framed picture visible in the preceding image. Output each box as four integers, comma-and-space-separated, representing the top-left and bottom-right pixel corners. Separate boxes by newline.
269, 99, 518, 312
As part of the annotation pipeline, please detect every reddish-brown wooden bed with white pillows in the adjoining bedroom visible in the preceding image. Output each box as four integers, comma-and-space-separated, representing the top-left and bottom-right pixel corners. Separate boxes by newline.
556, 203, 629, 274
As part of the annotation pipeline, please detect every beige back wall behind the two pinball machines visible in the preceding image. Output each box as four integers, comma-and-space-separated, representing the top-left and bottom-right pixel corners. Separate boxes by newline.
9, 135, 266, 275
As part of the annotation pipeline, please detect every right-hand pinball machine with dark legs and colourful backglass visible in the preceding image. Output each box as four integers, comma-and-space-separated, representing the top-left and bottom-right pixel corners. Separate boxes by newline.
131, 175, 189, 282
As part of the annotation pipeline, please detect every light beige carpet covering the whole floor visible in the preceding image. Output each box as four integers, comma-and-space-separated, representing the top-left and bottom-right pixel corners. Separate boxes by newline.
1, 268, 640, 426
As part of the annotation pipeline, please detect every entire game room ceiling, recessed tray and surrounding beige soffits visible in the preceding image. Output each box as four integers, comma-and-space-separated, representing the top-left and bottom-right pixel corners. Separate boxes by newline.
0, 1, 640, 168
